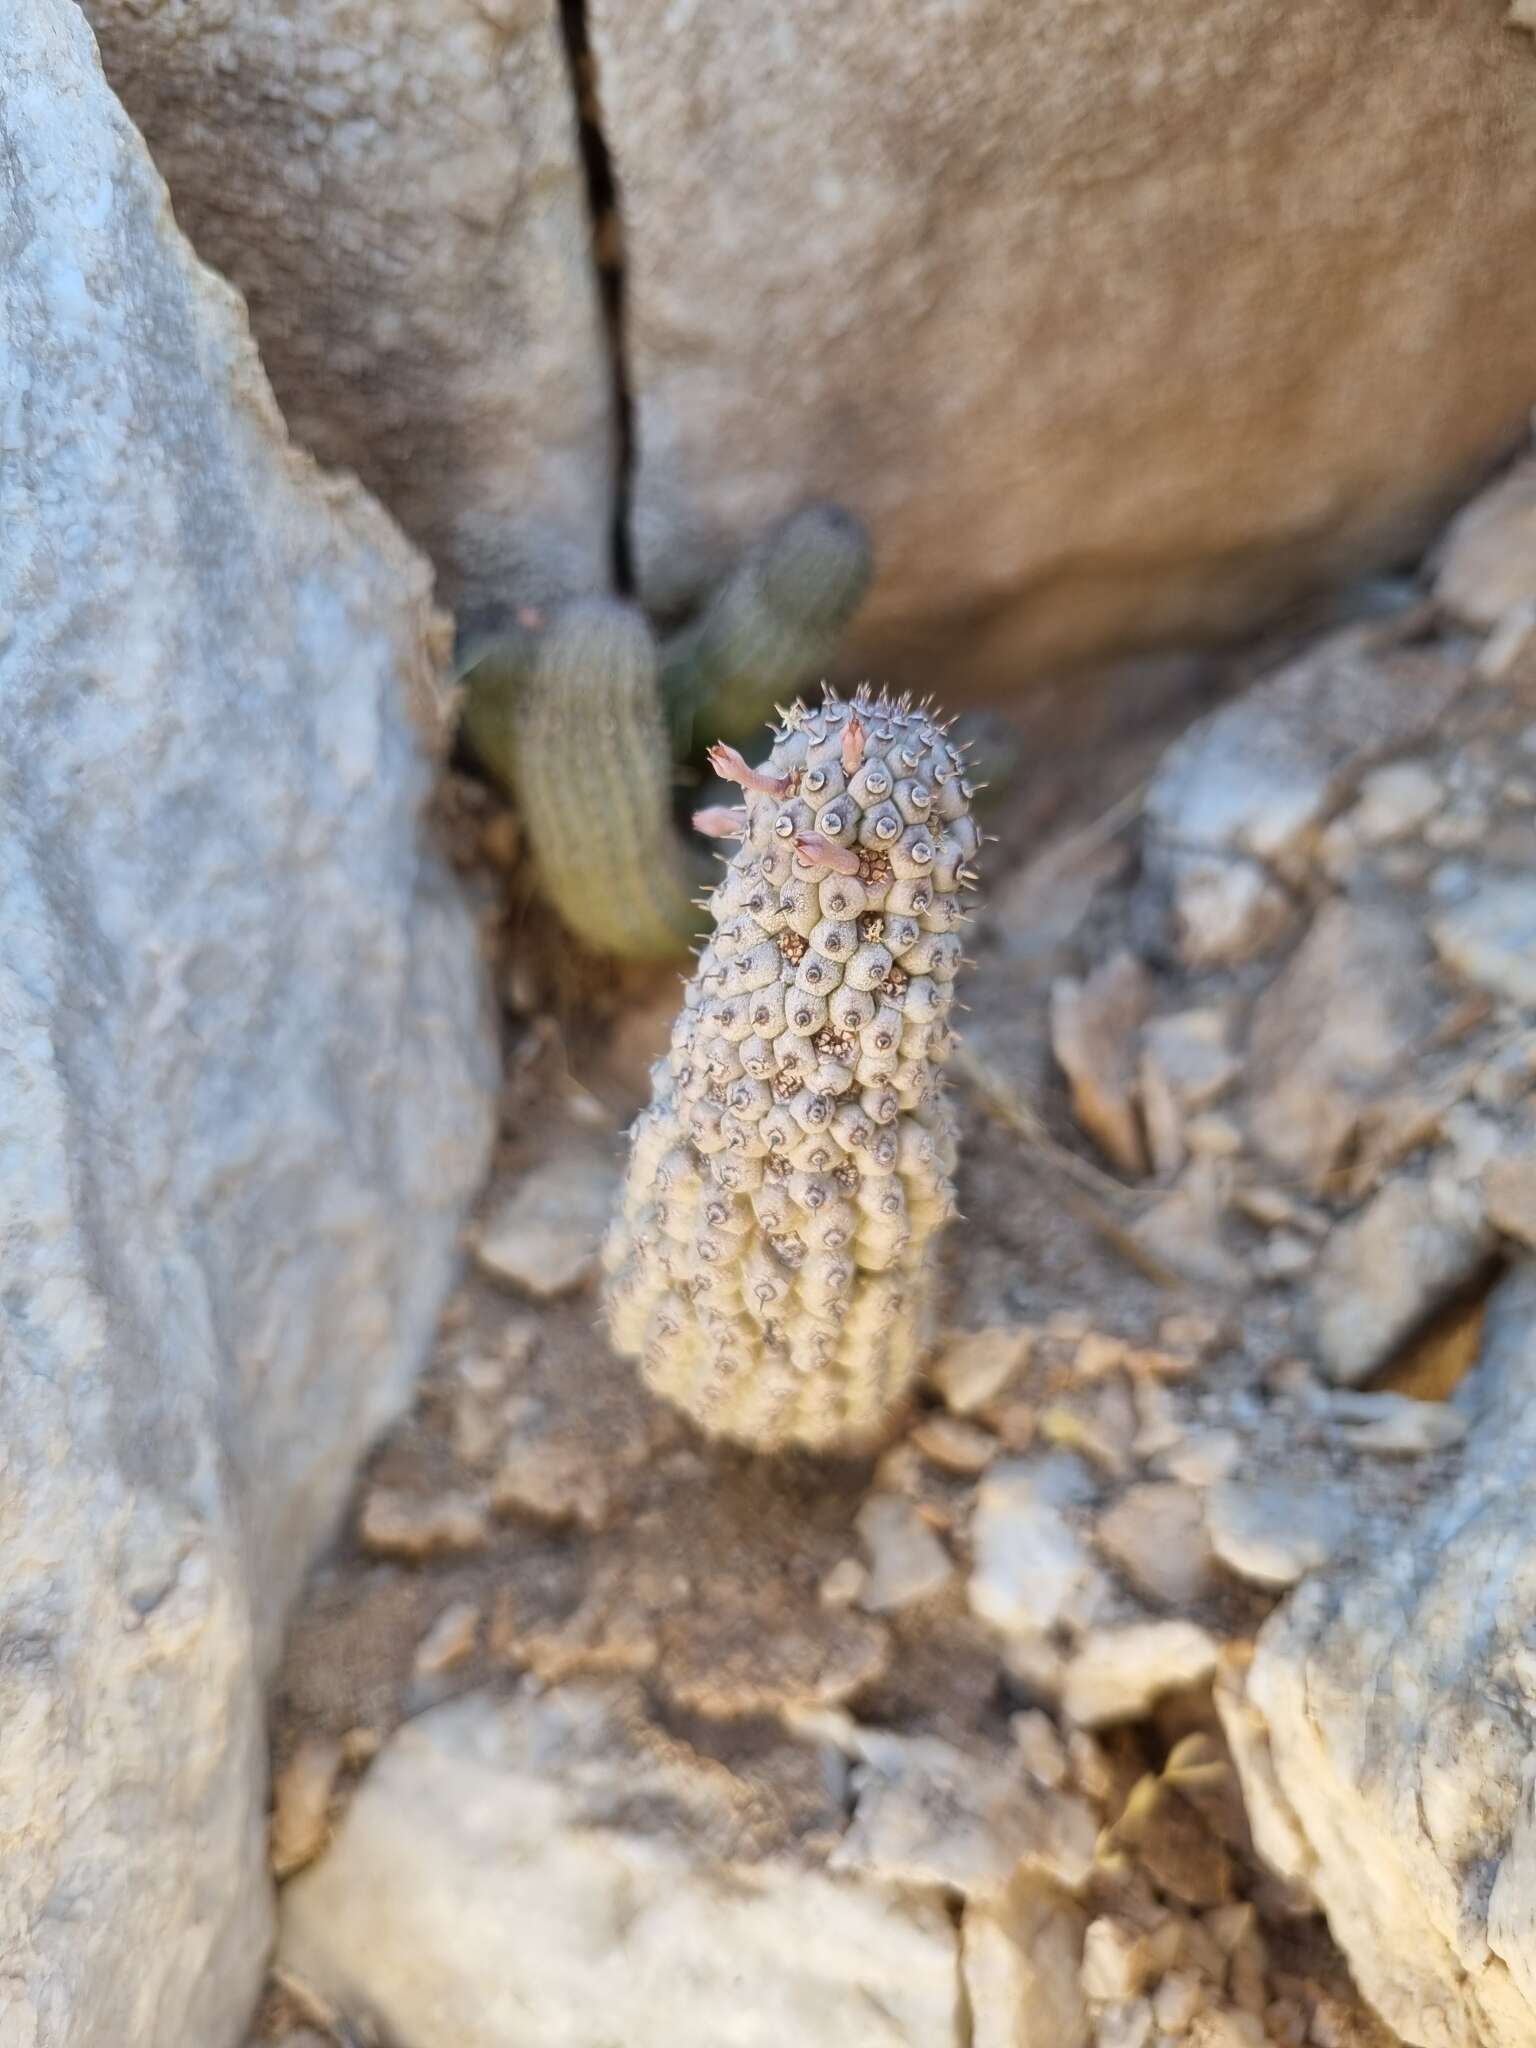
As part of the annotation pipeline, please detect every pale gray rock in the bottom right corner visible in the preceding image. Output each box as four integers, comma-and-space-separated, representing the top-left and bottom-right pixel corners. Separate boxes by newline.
1225, 1270, 1536, 2048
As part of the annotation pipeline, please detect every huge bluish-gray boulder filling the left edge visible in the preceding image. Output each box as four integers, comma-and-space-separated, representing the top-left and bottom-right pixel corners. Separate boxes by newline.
0, 0, 489, 2048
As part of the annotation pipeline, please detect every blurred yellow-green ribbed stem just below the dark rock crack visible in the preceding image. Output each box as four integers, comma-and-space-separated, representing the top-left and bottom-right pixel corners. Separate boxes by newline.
465, 598, 702, 961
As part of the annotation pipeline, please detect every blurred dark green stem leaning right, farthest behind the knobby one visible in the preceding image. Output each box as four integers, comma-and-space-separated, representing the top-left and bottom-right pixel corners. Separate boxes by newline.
662, 504, 872, 756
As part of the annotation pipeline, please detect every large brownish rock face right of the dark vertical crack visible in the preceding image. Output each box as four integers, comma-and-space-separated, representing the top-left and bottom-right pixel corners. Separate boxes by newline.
588, 0, 1536, 690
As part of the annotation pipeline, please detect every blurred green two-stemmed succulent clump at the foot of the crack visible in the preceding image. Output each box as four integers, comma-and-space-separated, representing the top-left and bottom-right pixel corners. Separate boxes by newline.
450, 506, 870, 958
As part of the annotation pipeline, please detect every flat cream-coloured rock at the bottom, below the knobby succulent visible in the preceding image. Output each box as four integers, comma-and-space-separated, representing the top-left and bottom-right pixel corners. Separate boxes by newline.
283, 1686, 961, 2048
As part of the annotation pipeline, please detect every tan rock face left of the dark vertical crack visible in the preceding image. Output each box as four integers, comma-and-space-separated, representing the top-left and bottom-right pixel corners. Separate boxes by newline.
86, 0, 612, 606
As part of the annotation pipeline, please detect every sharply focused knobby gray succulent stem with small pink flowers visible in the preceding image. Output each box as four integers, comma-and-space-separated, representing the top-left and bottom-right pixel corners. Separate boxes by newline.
604, 696, 979, 1450
